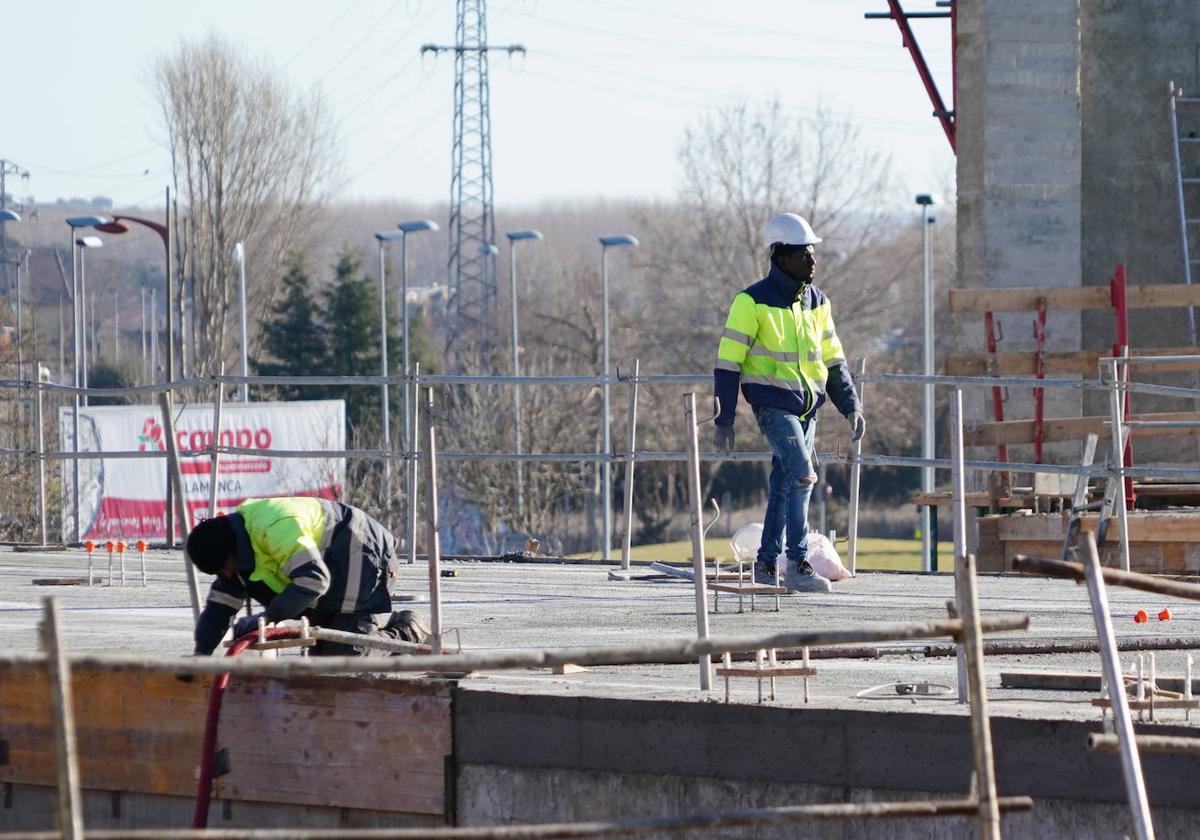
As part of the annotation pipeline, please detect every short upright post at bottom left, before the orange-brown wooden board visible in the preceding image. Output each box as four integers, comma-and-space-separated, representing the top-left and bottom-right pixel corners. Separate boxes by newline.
41, 598, 84, 840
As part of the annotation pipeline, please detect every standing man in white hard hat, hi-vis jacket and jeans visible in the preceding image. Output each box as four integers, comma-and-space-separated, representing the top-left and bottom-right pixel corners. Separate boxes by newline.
713, 212, 866, 592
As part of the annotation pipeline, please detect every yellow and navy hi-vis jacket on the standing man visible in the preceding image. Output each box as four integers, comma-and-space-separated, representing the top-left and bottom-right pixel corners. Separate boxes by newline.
713, 264, 860, 426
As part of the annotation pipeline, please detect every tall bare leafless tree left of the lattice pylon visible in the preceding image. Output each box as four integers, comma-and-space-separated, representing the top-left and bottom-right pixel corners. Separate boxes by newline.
151, 35, 335, 374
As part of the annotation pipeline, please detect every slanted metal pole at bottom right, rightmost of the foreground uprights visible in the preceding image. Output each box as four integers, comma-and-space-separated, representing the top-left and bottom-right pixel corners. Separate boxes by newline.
1081, 530, 1154, 840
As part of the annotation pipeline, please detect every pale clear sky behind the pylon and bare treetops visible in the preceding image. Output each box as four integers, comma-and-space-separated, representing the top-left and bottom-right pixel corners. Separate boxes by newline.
0, 0, 954, 204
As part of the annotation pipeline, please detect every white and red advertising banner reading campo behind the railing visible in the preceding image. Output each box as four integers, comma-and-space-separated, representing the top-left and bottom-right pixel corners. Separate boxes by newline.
59, 400, 346, 540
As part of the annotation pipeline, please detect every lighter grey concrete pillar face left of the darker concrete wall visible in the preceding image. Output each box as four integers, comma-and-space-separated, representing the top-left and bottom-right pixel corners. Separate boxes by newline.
955, 0, 1089, 460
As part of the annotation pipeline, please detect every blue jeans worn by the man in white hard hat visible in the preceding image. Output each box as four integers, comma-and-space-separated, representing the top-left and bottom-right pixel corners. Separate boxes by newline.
755, 408, 816, 569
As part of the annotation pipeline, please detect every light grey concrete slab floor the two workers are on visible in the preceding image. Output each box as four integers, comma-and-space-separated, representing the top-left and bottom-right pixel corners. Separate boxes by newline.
0, 547, 1200, 722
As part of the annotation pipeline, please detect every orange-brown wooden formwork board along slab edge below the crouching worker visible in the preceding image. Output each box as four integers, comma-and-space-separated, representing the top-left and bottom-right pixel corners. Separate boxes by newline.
0, 666, 451, 815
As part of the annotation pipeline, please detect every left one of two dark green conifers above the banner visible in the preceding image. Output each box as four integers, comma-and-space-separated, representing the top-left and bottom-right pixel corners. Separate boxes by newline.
254, 253, 326, 400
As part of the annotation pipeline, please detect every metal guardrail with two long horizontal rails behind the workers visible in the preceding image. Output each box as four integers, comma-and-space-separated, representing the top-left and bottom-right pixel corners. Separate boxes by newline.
0, 355, 1200, 572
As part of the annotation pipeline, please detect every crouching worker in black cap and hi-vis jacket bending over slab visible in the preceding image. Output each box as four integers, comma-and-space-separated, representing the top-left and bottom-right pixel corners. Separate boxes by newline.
187, 498, 428, 655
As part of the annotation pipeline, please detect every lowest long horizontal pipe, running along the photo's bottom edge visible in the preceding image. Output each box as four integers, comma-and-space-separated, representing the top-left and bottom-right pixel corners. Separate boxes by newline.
0, 797, 1033, 840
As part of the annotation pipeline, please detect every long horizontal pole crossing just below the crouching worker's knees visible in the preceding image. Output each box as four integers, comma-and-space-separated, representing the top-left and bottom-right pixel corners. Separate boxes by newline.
0, 616, 1030, 677
